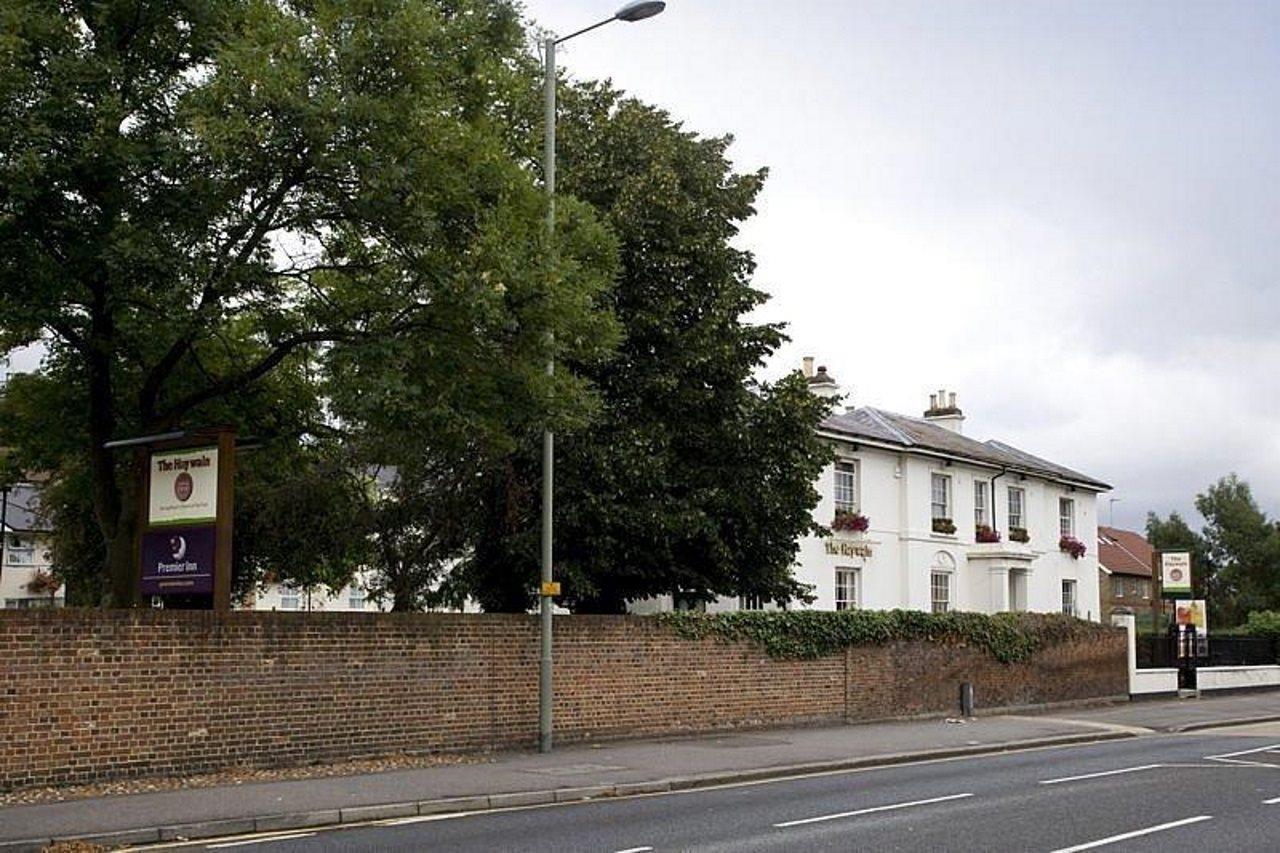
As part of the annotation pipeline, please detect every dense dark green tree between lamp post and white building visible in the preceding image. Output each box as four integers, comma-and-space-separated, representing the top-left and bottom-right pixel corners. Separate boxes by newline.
460, 85, 827, 612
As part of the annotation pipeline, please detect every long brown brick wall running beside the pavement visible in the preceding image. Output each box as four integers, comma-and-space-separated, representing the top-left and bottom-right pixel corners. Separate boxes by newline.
0, 611, 1128, 789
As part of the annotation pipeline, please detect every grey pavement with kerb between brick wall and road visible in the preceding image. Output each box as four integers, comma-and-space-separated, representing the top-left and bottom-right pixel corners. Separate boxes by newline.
0, 692, 1280, 850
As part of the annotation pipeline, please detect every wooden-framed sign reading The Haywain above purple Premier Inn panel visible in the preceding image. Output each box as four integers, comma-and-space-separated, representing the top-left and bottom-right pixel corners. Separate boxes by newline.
138, 429, 236, 612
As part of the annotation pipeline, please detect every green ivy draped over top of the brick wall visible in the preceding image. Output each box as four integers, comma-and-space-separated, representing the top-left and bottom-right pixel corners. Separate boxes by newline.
655, 610, 1115, 663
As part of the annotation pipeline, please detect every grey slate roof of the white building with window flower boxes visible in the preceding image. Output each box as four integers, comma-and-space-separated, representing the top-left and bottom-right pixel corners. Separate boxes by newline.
822, 406, 1111, 491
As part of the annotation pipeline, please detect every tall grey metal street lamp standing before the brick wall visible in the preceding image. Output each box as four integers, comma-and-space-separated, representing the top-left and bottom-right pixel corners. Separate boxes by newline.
538, 0, 667, 752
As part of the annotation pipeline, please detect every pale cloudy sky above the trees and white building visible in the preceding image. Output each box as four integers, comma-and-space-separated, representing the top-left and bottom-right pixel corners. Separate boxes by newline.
525, 0, 1280, 529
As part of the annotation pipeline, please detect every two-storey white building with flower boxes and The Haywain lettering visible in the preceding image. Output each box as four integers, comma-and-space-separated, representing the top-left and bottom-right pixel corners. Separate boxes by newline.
635, 359, 1110, 620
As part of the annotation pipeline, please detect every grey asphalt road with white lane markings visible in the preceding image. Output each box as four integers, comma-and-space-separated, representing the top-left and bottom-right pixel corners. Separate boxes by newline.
148, 724, 1280, 853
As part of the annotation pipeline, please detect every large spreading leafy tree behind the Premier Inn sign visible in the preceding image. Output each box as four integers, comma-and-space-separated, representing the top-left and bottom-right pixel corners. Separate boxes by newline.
0, 0, 612, 606
